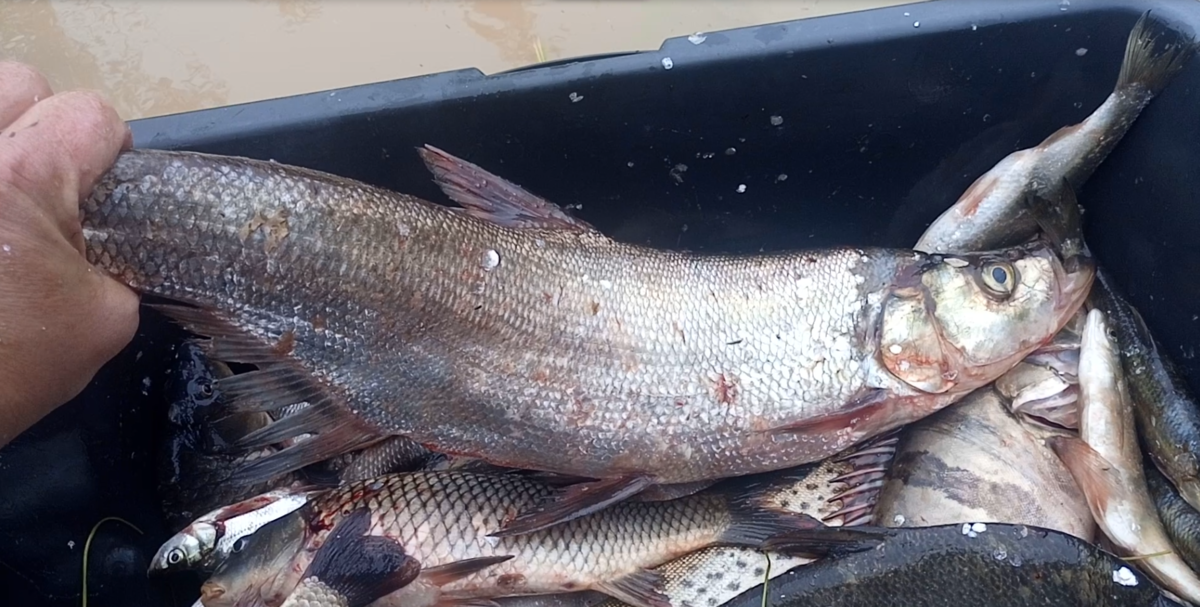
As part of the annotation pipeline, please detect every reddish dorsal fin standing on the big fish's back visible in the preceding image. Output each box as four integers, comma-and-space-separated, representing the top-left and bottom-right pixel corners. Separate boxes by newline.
416, 145, 596, 232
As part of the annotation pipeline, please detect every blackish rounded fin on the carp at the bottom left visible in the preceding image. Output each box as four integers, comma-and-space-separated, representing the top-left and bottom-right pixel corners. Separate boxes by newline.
301, 507, 421, 607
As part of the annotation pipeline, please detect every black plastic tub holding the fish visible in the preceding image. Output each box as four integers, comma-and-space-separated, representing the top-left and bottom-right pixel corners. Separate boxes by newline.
0, 0, 1200, 607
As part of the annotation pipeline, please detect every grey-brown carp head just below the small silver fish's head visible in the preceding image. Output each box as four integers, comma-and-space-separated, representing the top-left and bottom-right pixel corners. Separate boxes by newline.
200, 512, 307, 607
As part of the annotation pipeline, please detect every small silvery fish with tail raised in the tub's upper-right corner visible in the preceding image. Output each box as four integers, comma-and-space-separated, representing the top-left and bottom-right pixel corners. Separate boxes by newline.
914, 11, 1195, 253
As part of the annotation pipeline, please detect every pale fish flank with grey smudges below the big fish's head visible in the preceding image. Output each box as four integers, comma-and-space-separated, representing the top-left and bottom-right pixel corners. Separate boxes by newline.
875, 386, 1096, 541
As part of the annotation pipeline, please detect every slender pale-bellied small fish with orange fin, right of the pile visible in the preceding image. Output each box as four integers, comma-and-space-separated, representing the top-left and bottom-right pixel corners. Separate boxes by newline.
1048, 309, 1200, 605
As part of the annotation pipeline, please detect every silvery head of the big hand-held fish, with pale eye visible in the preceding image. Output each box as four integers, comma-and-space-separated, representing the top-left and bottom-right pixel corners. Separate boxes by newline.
878, 239, 1094, 393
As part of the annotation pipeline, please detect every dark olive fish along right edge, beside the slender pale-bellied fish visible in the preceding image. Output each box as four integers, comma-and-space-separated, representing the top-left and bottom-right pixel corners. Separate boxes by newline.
1088, 271, 1200, 510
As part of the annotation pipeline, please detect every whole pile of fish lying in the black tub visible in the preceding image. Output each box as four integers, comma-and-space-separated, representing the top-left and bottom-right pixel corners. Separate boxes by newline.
75, 8, 1200, 607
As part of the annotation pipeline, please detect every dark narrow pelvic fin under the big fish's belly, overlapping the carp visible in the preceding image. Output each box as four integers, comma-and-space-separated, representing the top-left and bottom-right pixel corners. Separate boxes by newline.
490, 476, 653, 537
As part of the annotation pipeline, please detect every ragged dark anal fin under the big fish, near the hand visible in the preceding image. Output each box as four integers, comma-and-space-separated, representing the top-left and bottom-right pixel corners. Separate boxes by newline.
146, 302, 380, 483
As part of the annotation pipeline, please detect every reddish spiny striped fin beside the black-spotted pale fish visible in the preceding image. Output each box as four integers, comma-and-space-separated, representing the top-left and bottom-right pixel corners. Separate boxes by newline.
822, 429, 900, 527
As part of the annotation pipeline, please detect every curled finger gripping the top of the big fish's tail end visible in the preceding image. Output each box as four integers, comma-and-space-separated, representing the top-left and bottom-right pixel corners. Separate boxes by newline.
0, 91, 130, 211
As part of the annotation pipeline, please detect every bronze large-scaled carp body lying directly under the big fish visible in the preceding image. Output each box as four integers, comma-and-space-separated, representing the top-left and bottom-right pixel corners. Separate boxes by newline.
312, 473, 731, 593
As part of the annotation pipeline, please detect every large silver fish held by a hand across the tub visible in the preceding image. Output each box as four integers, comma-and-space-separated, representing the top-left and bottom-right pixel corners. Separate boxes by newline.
83, 145, 1091, 525
